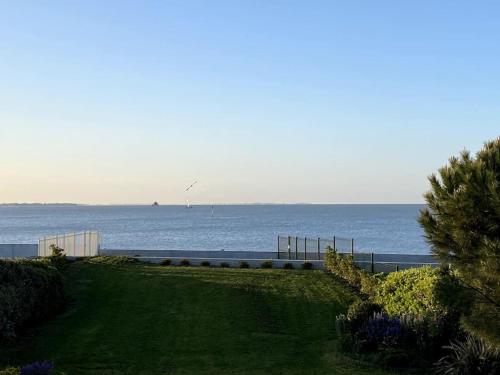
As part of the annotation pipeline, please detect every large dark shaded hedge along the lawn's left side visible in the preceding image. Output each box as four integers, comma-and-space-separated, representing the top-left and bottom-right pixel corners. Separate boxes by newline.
0, 260, 65, 341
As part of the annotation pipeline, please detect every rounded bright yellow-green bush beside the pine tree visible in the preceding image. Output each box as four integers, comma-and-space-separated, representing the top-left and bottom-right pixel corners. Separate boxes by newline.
374, 267, 447, 317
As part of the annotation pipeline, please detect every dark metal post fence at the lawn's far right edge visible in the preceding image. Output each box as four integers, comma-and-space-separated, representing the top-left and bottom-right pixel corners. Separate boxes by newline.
277, 236, 439, 273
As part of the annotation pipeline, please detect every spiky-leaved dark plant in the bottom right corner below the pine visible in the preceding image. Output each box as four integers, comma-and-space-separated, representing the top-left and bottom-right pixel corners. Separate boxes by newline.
436, 335, 500, 375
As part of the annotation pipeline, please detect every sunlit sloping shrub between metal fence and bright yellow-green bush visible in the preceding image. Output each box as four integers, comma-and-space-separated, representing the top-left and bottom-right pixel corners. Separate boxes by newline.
325, 248, 380, 296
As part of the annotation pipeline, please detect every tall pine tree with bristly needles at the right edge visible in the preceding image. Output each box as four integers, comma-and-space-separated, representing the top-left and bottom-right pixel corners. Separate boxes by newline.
419, 138, 500, 345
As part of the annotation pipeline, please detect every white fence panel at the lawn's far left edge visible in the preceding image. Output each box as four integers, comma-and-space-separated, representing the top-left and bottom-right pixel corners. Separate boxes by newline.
38, 231, 101, 257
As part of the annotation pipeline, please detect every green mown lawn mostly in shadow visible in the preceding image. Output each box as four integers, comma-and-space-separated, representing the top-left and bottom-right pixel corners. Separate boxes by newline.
0, 262, 396, 375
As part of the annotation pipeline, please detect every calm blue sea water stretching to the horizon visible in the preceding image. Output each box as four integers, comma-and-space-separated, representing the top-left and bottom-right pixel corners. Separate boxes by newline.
0, 205, 429, 254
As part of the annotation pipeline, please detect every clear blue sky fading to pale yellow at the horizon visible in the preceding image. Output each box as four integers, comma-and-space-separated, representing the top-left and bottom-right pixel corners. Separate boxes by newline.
0, 0, 500, 204
